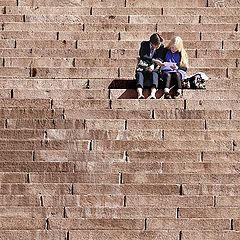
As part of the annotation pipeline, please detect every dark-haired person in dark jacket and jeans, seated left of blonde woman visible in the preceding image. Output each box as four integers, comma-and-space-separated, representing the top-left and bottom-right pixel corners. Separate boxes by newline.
136, 33, 164, 99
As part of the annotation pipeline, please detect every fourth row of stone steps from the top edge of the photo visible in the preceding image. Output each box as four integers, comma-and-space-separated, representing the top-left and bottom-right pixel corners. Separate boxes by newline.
3, 21, 238, 34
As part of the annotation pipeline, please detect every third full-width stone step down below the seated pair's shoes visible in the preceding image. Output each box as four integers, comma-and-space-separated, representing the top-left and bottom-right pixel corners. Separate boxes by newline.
2, 119, 206, 130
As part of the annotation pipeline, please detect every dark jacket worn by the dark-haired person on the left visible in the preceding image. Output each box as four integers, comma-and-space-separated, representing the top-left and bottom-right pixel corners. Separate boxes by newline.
139, 41, 164, 64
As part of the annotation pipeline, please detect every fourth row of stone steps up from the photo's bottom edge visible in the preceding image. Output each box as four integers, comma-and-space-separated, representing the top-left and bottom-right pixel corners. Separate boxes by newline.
0, 195, 216, 208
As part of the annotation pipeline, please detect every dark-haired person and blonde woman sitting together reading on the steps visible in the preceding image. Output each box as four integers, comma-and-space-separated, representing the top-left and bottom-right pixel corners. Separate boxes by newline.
136, 33, 188, 99
